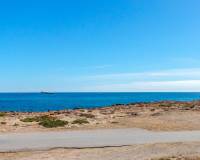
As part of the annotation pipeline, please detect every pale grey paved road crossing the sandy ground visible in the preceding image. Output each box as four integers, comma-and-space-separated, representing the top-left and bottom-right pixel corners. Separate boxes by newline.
0, 128, 200, 152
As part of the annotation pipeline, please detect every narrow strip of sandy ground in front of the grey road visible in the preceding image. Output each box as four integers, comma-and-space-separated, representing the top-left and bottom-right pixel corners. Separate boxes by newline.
0, 143, 200, 160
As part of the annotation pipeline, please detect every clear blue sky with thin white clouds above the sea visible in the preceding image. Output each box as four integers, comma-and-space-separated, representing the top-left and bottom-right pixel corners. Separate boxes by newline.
0, 0, 200, 92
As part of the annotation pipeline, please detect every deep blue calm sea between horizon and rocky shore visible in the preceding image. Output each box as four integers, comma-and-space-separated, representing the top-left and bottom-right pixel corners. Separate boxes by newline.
0, 93, 200, 112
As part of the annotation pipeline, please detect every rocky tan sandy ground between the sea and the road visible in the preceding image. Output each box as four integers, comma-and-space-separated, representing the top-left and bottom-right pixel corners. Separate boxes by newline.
0, 101, 200, 133
